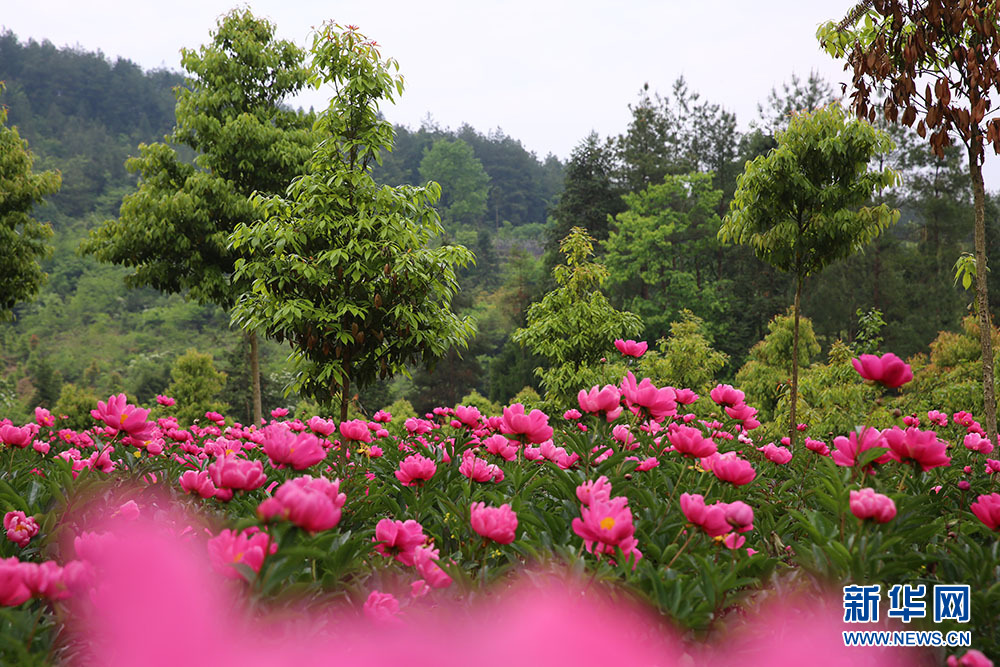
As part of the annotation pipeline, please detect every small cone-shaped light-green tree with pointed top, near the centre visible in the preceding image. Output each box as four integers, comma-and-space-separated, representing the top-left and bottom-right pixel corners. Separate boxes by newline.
511, 227, 642, 402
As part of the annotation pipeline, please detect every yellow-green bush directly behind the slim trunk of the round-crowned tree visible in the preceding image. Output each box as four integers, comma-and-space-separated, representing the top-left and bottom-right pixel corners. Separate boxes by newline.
736, 309, 820, 421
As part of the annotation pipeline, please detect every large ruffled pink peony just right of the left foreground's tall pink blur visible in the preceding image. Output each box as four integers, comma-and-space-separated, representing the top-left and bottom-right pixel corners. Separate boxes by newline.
257, 476, 347, 533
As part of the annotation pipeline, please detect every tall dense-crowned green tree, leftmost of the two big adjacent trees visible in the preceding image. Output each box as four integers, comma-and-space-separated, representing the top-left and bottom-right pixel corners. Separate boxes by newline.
81, 9, 313, 424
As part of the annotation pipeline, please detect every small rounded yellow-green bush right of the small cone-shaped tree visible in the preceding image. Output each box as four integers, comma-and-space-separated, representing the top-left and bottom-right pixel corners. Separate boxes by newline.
640, 309, 728, 394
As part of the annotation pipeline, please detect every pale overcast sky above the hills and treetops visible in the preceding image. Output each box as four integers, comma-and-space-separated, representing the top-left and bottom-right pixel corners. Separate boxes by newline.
0, 0, 868, 160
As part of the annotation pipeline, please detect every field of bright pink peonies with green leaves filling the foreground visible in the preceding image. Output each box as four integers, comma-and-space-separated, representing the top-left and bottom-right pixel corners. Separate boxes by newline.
0, 341, 1000, 667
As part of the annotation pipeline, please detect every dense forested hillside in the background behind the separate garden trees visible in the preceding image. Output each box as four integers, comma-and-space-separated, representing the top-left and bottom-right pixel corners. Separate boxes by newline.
0, 32, 1000, 426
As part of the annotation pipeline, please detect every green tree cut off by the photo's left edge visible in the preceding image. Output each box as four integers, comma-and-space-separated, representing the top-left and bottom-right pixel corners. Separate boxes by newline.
0, 82, 61, 319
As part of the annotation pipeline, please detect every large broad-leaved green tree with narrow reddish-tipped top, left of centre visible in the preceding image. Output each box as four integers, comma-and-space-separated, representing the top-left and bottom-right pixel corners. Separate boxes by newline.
230, 23, 475, 419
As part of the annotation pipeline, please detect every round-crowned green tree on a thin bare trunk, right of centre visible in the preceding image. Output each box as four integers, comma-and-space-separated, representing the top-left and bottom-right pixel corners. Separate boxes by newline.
719, 105, 899, 444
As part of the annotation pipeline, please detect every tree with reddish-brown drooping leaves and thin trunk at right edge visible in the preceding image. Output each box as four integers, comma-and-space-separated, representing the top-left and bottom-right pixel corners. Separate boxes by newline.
817, 0, 1000, 442
